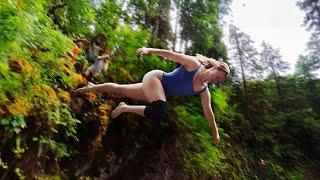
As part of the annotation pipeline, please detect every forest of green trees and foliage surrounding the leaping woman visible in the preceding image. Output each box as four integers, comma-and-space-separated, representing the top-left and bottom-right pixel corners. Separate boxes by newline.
0, 0, 320, 180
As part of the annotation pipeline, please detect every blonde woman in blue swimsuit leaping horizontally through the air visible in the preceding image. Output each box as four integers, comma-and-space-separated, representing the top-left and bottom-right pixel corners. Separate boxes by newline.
77, 48, 230, 144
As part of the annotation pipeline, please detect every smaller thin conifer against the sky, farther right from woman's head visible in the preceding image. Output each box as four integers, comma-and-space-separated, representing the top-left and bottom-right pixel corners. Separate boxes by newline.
260, 41, 289, 99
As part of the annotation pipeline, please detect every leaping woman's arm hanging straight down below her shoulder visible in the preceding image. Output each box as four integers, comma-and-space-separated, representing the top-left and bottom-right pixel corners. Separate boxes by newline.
200, 89, 220, 144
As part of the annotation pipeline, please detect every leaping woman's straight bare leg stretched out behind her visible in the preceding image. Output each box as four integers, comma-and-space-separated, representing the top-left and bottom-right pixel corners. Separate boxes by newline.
75, 82, 147, 101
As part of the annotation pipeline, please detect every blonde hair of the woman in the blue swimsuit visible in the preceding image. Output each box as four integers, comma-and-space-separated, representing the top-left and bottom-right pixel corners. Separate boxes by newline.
196, 54, 230, 75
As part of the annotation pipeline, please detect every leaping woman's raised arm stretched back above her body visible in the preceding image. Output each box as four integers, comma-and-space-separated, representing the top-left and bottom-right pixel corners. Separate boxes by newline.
137, 48, 199, 70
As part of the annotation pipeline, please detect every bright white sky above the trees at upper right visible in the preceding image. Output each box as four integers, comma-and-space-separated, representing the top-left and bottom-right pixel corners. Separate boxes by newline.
224, 0, 311, 73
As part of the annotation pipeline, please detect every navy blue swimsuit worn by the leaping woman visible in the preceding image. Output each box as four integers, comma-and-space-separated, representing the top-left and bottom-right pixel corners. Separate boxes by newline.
162, 64, 207, 96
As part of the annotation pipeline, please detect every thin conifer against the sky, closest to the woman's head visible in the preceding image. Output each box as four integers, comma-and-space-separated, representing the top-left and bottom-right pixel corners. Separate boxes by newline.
229, 25, 261, 103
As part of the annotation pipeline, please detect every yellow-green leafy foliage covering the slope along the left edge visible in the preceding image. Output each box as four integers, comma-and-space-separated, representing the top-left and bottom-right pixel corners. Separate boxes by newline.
0, 0, 84, 178
